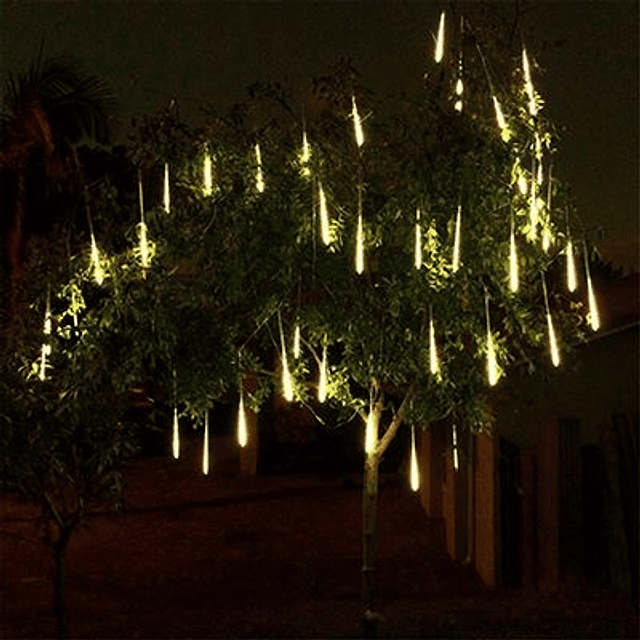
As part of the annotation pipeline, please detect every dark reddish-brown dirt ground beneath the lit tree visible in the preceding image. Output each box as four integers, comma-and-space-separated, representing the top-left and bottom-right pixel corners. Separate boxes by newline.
0, 444, 638, 639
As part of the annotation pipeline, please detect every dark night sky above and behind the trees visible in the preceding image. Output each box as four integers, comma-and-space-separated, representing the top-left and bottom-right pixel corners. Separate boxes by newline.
0, 0, 639, 268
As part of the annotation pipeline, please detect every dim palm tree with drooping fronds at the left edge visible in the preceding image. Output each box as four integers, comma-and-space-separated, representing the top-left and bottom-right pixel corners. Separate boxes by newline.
0, 57, 114, 318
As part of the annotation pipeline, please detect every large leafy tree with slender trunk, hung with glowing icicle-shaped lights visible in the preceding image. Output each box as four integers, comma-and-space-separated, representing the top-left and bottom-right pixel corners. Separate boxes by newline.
2, 12, 593, 633
